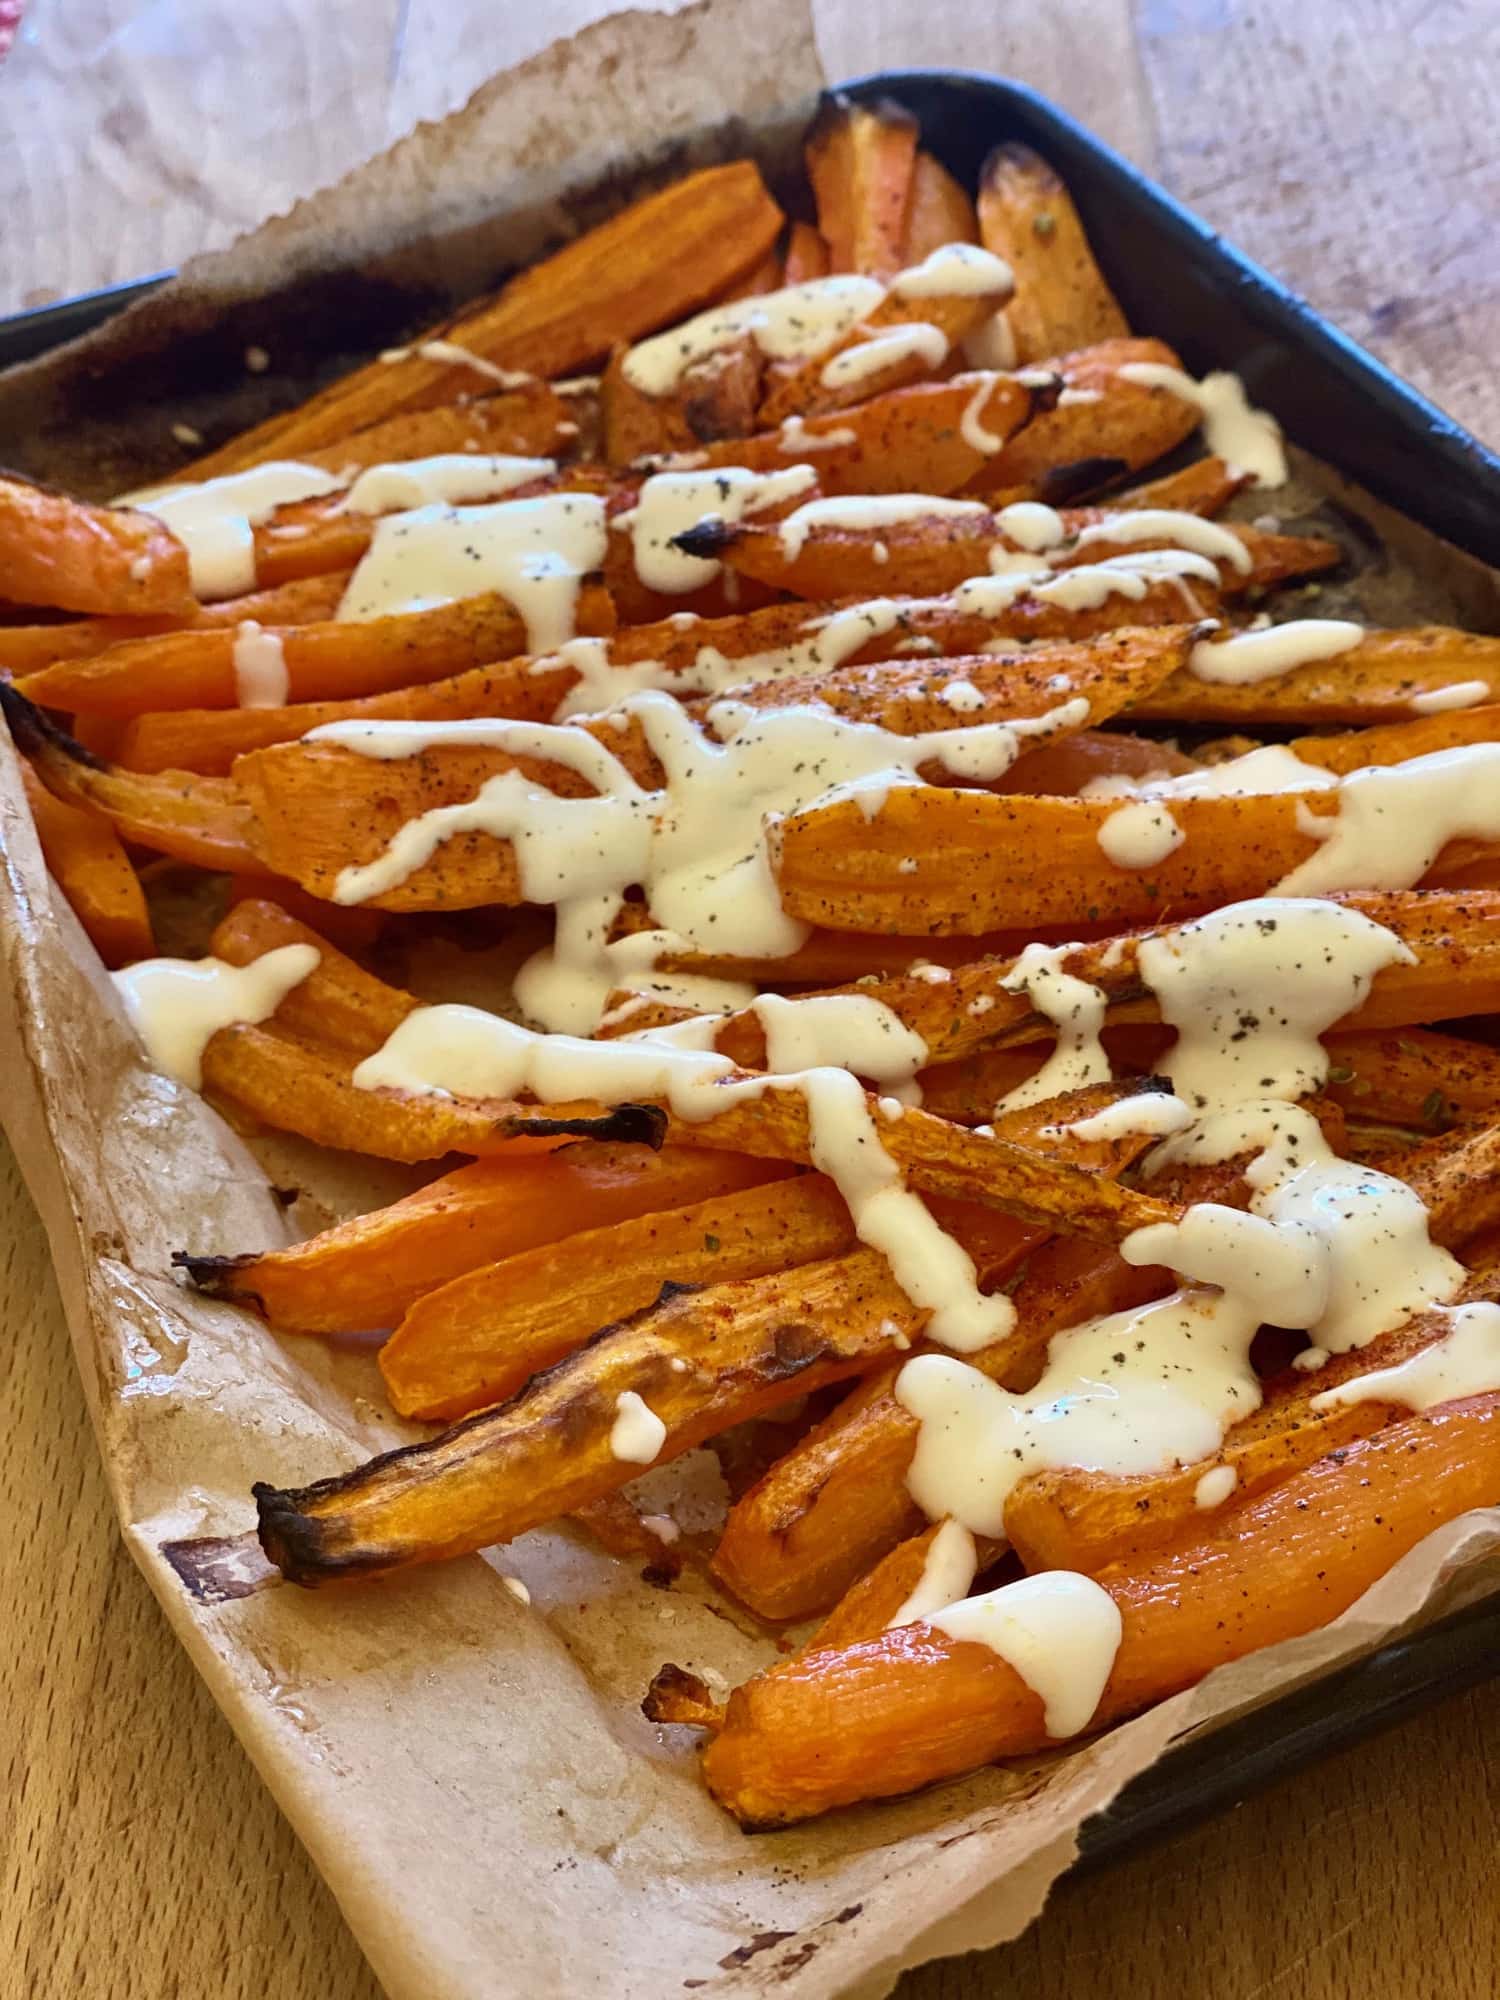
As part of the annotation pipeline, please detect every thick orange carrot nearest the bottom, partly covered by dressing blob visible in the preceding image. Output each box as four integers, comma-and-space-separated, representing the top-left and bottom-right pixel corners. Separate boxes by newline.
704, 1396, 1500, 1826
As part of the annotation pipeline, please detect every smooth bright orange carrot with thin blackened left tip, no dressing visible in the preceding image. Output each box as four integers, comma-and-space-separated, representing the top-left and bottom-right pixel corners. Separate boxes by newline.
174, 1140, 780, 1334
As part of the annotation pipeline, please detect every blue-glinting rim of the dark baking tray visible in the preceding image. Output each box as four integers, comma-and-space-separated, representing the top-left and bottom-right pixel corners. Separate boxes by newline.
11, 50, 1500, 1904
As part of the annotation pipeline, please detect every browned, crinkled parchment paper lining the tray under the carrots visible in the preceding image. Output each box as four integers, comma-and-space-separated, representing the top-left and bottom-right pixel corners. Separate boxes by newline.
0, 0, 1500, 2000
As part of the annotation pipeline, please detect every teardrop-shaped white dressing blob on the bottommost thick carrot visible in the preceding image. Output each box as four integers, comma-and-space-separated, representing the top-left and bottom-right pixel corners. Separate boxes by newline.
928, 1570, 1122, 1742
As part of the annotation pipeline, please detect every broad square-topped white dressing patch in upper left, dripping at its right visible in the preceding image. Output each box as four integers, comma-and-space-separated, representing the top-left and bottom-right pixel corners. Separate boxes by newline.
338, 494, 606, 652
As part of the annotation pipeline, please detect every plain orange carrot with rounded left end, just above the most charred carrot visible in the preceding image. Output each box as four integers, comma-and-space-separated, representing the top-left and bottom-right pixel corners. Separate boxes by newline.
380, 1174, 854, 1422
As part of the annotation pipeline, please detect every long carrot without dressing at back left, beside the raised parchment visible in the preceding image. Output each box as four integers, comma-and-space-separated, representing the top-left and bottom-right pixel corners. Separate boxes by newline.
186, 160, 782, 478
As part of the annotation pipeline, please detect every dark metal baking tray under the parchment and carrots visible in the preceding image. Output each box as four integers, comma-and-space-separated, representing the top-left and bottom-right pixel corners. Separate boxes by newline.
0, 70, 1500, 1896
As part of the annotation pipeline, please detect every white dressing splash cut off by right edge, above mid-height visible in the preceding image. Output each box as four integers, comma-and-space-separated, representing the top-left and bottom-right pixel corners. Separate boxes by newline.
1276, 742, 1500, 896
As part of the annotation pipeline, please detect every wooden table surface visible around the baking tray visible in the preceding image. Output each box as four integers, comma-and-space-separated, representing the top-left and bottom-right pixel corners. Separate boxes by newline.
0, 0, 1500, 2000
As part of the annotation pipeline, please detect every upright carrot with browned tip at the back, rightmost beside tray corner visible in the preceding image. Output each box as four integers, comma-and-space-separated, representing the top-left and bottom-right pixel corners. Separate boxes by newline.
978, 144, 1130, 362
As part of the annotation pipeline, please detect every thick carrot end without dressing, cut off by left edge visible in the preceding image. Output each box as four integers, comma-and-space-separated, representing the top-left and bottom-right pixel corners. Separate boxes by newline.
0, 476, 198, 618
